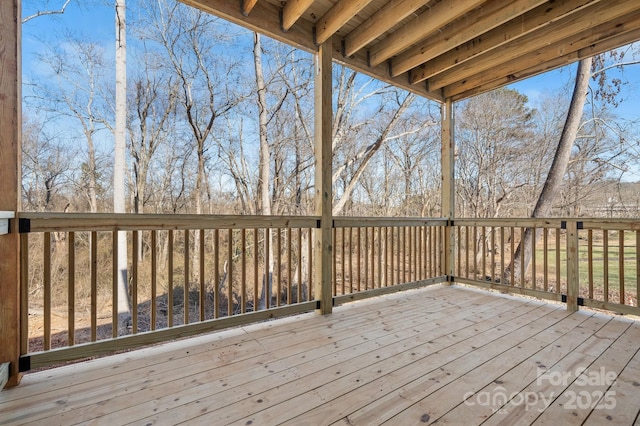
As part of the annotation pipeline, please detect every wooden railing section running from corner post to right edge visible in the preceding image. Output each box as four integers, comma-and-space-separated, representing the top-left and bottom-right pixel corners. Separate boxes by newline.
453, 219, 640, 315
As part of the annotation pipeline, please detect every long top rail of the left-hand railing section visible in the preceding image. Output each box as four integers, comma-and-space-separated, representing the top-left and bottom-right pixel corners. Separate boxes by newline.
19, 213, 320, 232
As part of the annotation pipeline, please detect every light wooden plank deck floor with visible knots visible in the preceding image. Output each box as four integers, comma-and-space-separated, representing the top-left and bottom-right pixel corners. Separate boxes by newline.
0, 286, 640, 425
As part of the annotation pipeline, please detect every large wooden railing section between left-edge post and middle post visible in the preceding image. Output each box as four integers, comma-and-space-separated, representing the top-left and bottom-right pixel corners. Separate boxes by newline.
20, 213, 318, 370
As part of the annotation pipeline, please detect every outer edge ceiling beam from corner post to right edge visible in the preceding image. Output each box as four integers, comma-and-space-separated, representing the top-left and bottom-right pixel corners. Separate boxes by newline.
444, 12, 640, 100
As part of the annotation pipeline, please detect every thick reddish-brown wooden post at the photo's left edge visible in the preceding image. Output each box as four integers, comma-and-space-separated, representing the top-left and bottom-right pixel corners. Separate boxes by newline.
0, 0, 22, 387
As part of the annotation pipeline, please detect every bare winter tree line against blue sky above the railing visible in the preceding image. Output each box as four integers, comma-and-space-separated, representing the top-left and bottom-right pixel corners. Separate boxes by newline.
23, 0, 638, 217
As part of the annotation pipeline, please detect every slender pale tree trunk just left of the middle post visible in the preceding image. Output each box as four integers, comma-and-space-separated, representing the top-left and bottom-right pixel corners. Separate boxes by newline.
253, 33, 273, 309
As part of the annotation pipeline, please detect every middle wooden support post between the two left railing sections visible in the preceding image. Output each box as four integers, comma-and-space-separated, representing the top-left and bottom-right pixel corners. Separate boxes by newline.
313, 40, 333, 314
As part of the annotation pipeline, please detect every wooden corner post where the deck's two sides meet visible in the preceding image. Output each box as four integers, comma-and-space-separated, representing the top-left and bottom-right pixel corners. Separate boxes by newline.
440, 98, 456, 277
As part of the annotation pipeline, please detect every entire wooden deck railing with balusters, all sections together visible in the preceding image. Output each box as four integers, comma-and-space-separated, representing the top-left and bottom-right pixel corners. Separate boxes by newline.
19, 213, 640, 370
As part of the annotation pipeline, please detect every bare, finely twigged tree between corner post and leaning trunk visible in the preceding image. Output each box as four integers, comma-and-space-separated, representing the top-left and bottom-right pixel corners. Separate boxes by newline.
456, 89, 539, 218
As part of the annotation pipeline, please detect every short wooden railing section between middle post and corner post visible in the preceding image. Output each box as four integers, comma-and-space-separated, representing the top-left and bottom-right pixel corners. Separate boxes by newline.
332, 217, 447, 303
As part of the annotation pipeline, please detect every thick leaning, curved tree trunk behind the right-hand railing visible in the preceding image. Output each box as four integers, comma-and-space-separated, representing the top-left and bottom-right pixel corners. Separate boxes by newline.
503, 58, 593, 280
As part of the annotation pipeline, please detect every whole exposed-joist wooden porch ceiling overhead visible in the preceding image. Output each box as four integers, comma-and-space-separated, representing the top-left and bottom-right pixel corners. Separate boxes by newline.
180, 0, 640, 101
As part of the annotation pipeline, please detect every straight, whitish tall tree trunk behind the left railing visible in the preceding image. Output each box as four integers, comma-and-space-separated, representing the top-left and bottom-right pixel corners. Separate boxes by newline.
113, 0, 131, 333
